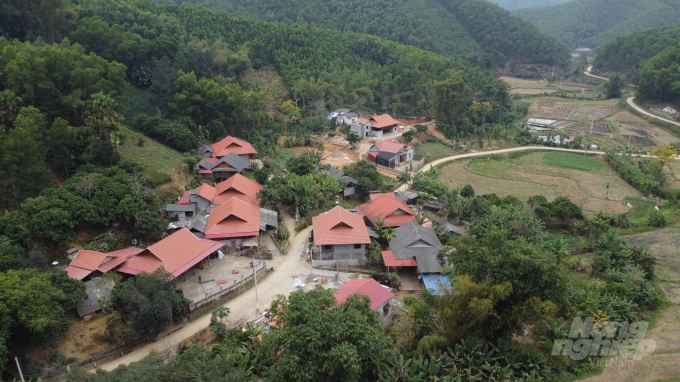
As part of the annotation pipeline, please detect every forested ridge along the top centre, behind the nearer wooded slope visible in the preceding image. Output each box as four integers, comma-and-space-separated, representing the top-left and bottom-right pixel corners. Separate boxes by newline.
165, 0, 567, 67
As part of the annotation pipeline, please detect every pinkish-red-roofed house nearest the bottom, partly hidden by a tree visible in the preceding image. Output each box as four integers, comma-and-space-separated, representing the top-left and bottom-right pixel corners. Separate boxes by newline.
333, 279, 394, 325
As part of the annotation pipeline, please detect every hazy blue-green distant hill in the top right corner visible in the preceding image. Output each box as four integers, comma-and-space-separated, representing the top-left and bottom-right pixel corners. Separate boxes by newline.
514, 0, 680, 48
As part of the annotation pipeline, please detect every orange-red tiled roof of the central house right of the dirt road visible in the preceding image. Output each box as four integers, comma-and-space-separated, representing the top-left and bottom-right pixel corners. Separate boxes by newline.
312, 206, 371, 245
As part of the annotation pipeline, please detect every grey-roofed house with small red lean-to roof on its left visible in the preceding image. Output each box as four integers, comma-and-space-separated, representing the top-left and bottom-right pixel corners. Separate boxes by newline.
382, 221, 443, 274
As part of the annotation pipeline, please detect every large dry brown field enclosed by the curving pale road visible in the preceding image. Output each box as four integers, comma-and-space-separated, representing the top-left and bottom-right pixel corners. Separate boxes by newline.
441, 152, 640, 213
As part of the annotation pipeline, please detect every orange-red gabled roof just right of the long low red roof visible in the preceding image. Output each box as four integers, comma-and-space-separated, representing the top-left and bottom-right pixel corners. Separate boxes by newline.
205, 198, 260, 239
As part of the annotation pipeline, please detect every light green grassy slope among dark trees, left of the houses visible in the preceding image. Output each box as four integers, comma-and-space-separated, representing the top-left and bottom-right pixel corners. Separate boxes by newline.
118, 126, 193, 191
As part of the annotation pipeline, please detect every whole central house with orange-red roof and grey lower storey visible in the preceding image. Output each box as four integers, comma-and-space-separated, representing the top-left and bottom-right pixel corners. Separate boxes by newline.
312, 206, 371, 262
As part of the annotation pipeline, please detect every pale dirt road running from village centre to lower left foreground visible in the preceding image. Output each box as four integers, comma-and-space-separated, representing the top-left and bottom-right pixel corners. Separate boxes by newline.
100, 224, 312, 371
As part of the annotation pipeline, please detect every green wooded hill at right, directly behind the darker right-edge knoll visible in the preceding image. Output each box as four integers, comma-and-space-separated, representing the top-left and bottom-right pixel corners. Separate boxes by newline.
593, 26, 680, 82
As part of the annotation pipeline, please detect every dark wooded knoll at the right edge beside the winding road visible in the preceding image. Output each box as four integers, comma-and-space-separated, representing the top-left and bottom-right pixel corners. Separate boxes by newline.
636, 43, 680, 103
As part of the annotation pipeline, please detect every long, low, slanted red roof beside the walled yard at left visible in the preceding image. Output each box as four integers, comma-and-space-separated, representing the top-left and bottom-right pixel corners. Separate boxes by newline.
118, 228, 224, 276
